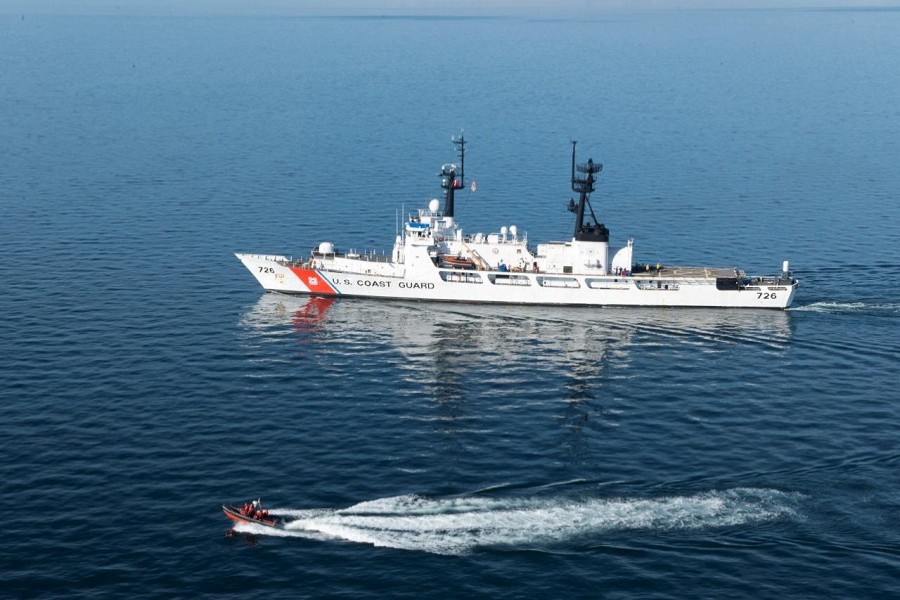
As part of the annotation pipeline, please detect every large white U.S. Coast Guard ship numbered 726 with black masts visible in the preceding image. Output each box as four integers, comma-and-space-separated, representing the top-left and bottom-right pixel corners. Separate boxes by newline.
235, 137, 798, 309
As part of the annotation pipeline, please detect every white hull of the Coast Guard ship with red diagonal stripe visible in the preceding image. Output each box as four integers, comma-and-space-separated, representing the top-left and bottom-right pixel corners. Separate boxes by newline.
235, 253, 798, 309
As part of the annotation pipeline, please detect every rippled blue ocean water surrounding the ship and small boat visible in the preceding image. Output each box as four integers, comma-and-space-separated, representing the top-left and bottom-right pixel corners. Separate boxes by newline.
0, 10, 900, 598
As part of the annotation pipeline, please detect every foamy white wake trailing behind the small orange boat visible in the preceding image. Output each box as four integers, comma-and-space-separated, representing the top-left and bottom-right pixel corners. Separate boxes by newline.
236, 488, 801, 555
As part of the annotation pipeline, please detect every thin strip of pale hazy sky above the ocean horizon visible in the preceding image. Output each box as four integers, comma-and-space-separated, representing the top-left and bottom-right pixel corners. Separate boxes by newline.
0, 0, 900, 16
